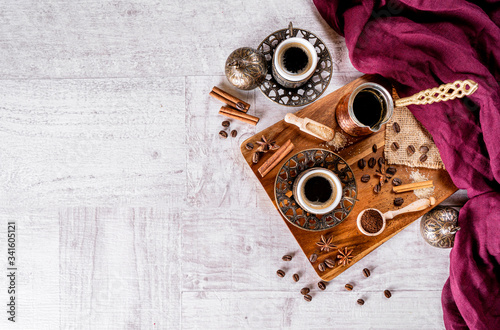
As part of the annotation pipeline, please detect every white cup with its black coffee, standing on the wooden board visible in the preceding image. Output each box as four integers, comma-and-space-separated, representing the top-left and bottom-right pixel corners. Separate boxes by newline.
292, 167, 342, 214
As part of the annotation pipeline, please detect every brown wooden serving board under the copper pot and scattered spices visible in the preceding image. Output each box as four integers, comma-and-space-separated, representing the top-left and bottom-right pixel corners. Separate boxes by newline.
241, 75, 457, 281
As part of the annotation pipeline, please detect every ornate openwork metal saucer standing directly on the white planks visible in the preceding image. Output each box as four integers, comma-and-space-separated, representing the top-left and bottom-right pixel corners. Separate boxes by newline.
258, 23, 333, 107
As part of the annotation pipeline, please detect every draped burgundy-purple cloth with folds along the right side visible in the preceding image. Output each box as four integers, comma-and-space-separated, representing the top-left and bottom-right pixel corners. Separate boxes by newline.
314, 0, 500, 329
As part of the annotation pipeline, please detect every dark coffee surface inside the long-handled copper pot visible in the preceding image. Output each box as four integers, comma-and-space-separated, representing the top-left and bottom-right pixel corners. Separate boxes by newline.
352, 90, 384, 127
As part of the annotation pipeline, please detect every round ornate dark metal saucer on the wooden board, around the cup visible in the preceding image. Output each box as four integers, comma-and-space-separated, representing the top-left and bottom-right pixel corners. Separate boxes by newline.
274, 149, 357, 231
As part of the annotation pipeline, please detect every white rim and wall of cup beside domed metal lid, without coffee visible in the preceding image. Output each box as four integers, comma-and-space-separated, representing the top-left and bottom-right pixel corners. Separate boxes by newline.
272, 37, 318, 88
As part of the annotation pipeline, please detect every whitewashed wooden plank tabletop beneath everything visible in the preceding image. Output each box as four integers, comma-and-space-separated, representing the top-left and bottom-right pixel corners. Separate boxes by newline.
0, 0, 467, 329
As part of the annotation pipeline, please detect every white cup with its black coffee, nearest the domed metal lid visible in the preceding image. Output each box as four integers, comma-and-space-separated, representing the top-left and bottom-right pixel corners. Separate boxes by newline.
272, 37, 318, 88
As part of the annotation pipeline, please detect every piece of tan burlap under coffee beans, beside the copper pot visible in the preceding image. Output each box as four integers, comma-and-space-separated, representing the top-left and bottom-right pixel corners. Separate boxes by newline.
384, 90, 444, 169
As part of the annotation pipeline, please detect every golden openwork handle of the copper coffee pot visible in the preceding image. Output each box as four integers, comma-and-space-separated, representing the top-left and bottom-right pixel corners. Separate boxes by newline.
394, 79, 479, 107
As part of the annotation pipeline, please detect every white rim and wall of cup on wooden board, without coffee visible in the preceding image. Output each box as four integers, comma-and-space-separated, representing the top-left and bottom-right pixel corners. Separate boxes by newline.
293, 167, 342, 214
